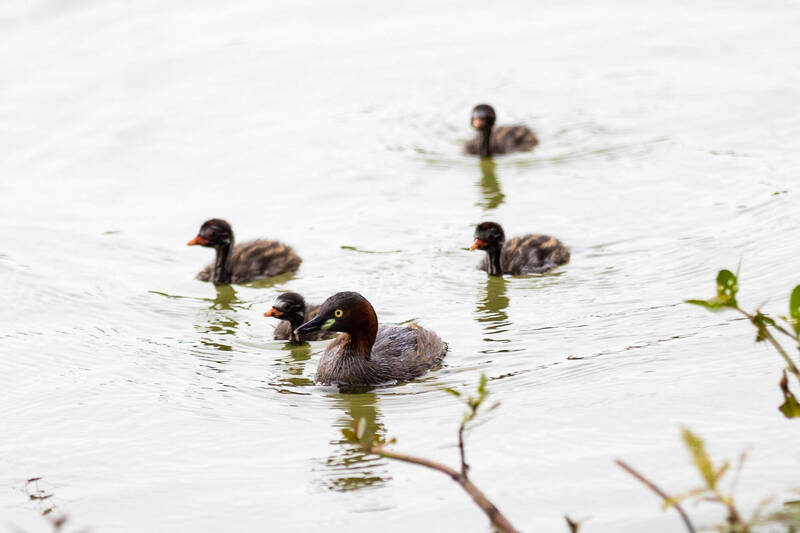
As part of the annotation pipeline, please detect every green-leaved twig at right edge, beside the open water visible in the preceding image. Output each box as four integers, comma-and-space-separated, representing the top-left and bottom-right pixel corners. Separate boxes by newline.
686, 270, 800, 418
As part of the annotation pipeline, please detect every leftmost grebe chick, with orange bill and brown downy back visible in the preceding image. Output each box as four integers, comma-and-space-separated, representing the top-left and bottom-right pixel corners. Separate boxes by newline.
186, 218, 301, 283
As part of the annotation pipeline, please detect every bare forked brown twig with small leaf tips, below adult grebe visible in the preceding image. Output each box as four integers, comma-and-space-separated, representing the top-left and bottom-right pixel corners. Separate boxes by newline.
342, 374, 518, 533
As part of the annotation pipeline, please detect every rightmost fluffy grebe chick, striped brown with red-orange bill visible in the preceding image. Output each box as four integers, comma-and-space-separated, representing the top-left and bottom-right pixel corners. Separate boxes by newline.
470, 222, 569, 276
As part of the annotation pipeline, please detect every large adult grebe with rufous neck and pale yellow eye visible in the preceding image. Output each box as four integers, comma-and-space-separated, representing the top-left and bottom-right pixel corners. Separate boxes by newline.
295, 292, 447, 386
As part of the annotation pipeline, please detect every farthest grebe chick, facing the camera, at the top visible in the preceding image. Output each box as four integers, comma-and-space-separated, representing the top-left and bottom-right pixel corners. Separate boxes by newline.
464, 104, 539, 157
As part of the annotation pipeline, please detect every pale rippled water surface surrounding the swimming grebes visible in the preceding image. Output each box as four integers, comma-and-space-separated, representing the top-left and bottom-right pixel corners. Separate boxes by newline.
0, 1, 800, 533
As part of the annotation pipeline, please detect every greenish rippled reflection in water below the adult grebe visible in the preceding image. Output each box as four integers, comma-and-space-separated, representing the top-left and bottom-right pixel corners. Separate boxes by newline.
322, 393, 391, 492
